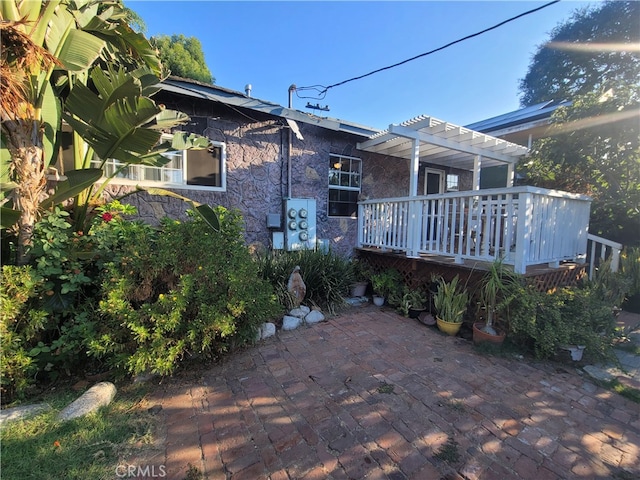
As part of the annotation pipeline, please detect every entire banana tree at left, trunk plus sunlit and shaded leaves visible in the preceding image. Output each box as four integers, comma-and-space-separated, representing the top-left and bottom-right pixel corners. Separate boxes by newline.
0, 0, 215, 264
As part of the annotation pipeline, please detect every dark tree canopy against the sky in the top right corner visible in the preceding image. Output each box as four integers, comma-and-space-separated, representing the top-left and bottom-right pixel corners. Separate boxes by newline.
520, 1, 640, 107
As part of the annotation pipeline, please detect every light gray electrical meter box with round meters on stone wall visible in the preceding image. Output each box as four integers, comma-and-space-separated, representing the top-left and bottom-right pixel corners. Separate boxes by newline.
283, 198, 317, 251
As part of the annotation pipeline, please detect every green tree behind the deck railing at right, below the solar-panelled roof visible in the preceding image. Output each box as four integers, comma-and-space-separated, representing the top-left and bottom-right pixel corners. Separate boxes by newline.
520, 86, 640, 245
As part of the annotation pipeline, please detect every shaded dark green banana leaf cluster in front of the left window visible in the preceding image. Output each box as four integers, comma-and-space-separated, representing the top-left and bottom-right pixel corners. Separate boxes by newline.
62, 67, 210, 230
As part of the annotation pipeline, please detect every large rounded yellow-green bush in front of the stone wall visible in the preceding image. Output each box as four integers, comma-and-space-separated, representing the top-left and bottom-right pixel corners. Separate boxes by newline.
89, 207, 280, 375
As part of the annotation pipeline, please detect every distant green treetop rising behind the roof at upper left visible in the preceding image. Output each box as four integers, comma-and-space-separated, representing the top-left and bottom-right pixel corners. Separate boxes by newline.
151, 34, 215, 83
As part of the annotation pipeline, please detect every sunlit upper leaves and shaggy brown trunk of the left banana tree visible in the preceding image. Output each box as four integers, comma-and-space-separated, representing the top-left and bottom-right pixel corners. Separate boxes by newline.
0, 0, 162, 263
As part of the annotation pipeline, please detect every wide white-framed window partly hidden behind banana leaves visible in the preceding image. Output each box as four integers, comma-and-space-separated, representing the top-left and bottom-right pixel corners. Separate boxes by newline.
91, 135, 226, 191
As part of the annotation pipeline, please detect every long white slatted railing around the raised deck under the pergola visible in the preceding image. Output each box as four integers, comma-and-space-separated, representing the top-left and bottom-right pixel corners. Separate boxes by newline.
358, 187, 591, 273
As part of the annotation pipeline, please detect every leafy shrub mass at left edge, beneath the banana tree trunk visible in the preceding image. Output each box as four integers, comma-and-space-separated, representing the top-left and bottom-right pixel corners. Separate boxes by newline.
1, 202, 142, 401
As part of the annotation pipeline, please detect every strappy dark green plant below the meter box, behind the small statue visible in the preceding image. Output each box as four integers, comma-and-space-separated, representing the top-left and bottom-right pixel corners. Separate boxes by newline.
257, 246, 355, 313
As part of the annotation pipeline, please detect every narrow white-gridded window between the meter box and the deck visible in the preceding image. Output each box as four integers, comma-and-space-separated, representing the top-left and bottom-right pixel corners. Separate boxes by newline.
329, 155, 362, 217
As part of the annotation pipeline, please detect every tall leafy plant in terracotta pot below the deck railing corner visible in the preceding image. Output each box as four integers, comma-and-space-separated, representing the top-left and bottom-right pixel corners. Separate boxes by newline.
473, 260, 519, 344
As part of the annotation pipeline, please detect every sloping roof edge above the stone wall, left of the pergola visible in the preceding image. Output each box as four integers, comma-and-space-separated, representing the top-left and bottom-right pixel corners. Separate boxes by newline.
162, 77, 379, 137
